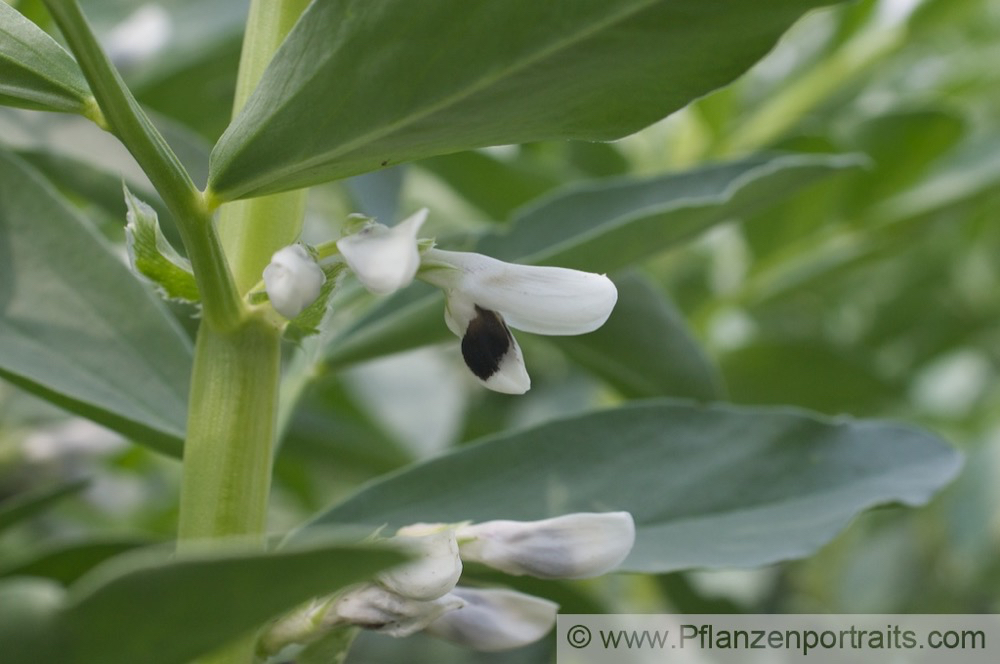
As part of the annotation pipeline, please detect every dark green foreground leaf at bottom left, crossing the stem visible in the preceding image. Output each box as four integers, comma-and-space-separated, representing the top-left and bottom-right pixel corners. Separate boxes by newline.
0, 542, 402, 664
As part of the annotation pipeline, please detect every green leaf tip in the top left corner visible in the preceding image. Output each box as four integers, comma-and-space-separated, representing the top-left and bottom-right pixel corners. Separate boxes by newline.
0, 2, 93, 113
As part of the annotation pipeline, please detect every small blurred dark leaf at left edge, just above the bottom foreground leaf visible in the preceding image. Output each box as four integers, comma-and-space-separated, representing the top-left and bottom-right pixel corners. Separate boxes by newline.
0, 537, 154, 585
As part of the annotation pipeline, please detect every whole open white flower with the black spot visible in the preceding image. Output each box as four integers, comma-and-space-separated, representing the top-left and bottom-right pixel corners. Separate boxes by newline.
420, 249, 618, 394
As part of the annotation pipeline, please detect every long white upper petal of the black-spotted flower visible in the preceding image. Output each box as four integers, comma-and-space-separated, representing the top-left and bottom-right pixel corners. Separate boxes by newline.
423, 249, 618, 335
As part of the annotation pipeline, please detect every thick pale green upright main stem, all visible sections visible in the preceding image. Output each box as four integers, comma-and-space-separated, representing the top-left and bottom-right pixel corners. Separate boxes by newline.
178, 0, 307, 664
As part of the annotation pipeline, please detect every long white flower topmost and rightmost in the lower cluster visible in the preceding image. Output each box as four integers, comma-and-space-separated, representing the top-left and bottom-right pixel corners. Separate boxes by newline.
458, 512, 635, 579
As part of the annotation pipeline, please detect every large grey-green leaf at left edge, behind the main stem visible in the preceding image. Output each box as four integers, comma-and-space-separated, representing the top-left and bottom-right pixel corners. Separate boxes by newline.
0, 152, 191, 454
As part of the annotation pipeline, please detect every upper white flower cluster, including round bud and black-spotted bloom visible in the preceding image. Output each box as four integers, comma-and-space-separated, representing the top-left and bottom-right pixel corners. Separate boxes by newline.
265, 209, 618, 394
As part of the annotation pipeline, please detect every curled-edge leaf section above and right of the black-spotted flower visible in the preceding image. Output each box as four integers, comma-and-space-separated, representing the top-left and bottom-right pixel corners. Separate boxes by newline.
478, 154, 867, 272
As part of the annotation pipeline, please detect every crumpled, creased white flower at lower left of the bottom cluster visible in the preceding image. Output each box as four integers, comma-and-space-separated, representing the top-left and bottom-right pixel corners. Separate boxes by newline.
332, 583, 465, 636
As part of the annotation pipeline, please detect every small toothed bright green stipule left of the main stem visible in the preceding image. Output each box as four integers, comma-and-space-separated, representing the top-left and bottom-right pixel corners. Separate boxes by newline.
124, 187, 201, 303
